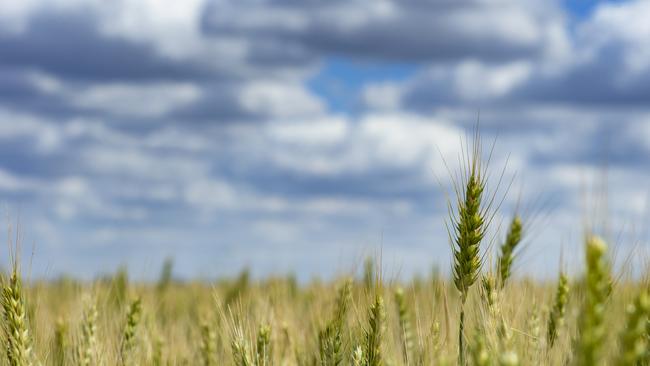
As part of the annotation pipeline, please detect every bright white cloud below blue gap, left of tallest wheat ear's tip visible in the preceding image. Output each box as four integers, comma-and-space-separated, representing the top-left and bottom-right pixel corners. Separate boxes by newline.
264, 112, 465, 176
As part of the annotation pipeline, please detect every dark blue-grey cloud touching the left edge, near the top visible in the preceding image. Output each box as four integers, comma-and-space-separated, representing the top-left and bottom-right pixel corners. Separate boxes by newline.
0, 11, 213, 81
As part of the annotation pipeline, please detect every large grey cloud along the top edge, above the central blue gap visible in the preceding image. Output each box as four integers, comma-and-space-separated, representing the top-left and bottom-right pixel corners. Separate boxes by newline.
203, 0, 557, 62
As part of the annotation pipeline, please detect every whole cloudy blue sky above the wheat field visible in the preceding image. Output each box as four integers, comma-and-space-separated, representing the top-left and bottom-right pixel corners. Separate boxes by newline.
0, 0, 650, 279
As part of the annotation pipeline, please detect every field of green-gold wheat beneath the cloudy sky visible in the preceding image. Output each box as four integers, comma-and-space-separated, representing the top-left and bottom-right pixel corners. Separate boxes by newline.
2, 137, 650, 366
